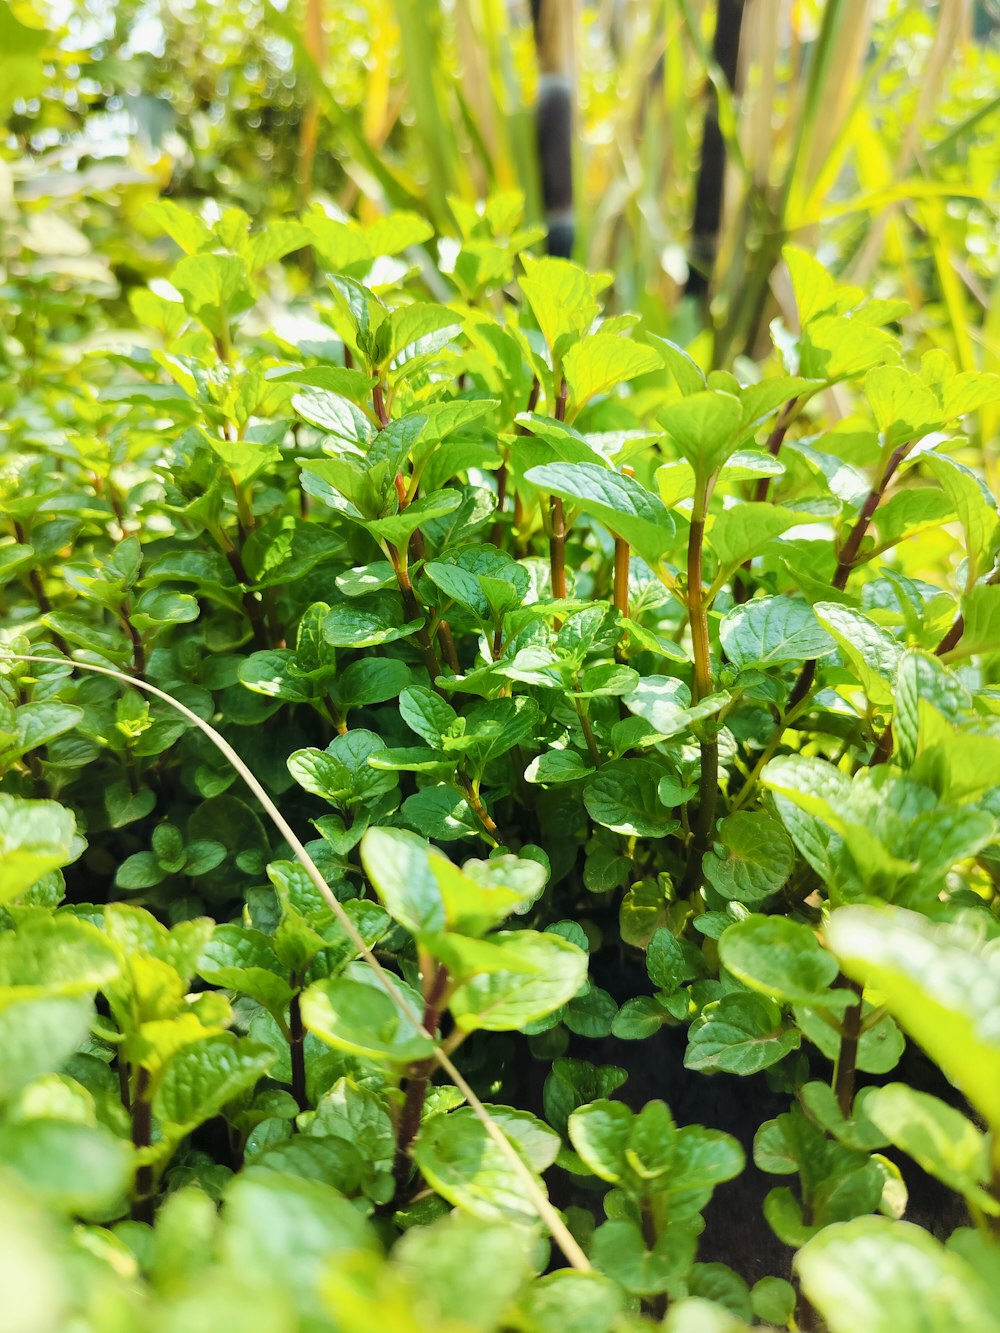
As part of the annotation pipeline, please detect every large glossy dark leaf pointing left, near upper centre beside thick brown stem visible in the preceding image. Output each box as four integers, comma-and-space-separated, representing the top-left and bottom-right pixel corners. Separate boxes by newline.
525, 463, 676, 569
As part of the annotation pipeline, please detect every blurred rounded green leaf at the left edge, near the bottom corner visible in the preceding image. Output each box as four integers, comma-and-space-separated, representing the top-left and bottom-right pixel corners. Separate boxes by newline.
0, 1118, 132, 1217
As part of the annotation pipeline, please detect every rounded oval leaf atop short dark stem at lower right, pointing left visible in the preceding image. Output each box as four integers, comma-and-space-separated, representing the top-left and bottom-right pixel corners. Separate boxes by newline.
719, 916, 853, 1009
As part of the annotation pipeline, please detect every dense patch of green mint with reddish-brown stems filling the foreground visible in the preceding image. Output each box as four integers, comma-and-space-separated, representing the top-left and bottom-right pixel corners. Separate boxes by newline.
0, 196, 1000, 1333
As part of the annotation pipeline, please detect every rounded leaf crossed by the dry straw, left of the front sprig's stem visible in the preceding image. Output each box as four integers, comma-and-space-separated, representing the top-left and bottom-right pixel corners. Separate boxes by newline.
300, 974, 433, 1065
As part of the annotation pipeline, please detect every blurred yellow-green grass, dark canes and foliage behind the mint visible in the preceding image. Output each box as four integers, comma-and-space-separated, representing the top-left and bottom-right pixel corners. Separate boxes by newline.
0, 0, 1000, 381
